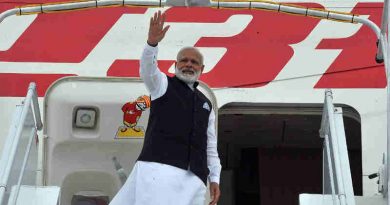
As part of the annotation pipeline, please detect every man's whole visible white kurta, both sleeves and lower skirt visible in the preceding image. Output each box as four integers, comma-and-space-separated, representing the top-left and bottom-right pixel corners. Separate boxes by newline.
110, 45, 221, 205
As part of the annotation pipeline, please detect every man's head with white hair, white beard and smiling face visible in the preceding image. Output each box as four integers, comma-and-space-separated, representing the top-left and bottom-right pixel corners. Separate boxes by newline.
175, 48, 204, 83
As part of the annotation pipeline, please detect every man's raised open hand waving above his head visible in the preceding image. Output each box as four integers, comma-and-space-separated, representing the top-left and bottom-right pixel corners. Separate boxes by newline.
148, 11, 169, 46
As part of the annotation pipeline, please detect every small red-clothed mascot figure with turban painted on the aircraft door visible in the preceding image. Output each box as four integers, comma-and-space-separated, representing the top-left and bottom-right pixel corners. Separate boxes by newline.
121, 95, 150, 132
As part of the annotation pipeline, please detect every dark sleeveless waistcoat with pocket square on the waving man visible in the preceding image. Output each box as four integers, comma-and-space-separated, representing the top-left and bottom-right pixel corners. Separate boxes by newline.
138, 77, 212, 184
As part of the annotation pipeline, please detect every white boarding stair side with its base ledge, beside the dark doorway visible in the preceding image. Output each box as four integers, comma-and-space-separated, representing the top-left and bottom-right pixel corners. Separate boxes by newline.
299, 90, 389, 205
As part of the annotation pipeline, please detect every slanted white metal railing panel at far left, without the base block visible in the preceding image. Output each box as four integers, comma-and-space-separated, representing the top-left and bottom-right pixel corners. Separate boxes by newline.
0, 83, 42, 205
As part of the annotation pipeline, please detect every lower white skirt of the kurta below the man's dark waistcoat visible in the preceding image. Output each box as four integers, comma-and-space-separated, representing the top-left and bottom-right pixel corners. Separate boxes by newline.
110, 161, 206, 205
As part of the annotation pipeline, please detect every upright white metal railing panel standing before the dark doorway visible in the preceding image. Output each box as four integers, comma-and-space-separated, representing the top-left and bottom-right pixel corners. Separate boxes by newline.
320, 90, 355, 205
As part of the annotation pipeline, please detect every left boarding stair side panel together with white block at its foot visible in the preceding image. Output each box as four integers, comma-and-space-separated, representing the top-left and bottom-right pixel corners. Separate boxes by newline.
0, 83, 60, 205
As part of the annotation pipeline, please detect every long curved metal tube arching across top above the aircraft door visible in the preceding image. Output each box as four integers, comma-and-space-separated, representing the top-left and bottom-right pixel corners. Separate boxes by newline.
0, 0, 382, 42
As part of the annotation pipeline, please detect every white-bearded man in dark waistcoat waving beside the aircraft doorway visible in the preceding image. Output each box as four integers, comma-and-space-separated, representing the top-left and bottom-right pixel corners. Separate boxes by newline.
110, 12, 221, 205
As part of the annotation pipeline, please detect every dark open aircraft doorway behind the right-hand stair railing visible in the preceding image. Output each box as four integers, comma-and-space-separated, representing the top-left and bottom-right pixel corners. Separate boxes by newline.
218, 103, 362, 205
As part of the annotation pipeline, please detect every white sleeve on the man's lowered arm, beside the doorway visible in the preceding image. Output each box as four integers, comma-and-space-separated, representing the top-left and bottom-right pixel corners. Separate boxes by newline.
207, 109, 222, 184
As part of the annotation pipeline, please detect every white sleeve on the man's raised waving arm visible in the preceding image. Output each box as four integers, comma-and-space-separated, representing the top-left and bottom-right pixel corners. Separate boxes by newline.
139, 45, 168, 100
